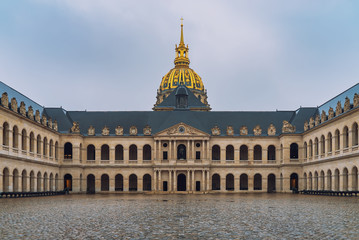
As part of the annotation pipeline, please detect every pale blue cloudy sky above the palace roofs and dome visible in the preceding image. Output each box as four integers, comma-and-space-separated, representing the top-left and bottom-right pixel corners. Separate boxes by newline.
0, 0, 359, 111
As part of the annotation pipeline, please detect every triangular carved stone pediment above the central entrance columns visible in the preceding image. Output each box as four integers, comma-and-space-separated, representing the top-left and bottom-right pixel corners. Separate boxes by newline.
155, 122, 209, 137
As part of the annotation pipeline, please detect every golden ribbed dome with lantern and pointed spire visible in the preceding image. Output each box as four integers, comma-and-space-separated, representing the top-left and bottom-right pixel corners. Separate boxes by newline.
159, 19, 205, 93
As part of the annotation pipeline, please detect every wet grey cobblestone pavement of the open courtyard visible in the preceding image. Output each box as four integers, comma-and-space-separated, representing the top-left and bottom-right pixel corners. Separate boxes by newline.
0, 194, 359, 239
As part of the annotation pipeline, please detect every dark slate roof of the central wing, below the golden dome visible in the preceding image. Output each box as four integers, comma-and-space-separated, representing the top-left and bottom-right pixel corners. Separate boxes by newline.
46, 108, 317, 136
